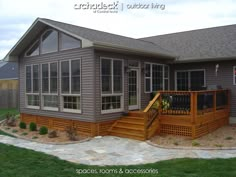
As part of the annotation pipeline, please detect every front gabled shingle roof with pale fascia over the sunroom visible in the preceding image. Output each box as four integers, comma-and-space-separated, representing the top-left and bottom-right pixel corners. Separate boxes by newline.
4, 18, 175, 61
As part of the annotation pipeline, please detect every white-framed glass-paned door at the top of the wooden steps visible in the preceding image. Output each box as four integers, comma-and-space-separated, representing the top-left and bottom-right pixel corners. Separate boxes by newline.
128, 69, 139, 110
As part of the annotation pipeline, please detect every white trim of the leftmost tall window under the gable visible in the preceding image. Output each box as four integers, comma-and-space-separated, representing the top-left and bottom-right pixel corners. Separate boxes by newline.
25, 64, 40, 109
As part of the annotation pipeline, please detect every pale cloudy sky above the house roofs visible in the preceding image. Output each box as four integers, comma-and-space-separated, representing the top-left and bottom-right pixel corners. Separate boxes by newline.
0, 0, 236, 59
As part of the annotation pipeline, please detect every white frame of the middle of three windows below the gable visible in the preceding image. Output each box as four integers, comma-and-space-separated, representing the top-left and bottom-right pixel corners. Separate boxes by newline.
41, 61, 59, 111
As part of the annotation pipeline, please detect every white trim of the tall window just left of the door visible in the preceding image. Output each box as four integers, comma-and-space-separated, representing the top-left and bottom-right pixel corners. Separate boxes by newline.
100, 57, 124, 114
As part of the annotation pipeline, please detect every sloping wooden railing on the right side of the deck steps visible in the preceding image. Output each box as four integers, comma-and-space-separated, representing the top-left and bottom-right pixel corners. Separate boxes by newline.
143, 93, 161, 129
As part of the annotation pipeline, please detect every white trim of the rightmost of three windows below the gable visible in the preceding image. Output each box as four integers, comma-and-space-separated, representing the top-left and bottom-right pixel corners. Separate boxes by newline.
59, 58, 82, 113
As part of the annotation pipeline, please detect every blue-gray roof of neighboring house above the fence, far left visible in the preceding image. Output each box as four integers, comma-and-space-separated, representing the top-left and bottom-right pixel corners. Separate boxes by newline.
0, 61, 18, 80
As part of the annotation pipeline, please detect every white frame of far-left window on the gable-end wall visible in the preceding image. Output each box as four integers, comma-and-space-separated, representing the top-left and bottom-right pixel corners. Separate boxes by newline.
25, 64, 40, 109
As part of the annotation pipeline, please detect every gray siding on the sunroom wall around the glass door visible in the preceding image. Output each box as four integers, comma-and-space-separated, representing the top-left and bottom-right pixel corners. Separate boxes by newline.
95, 50, 170, 122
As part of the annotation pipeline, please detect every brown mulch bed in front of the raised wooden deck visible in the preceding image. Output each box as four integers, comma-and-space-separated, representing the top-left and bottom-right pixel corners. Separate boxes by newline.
150, 126, 236, 148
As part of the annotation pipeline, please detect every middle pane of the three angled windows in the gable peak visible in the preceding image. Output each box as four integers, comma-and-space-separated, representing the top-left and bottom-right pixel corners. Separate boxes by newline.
41, 30, 58, 54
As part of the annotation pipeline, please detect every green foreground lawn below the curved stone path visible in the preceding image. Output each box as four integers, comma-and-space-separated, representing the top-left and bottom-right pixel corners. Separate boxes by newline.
0, 143, 236, 177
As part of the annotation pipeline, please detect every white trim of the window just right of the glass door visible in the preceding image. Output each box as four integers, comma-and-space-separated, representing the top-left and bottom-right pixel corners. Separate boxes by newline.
144, 62, 170, 93
